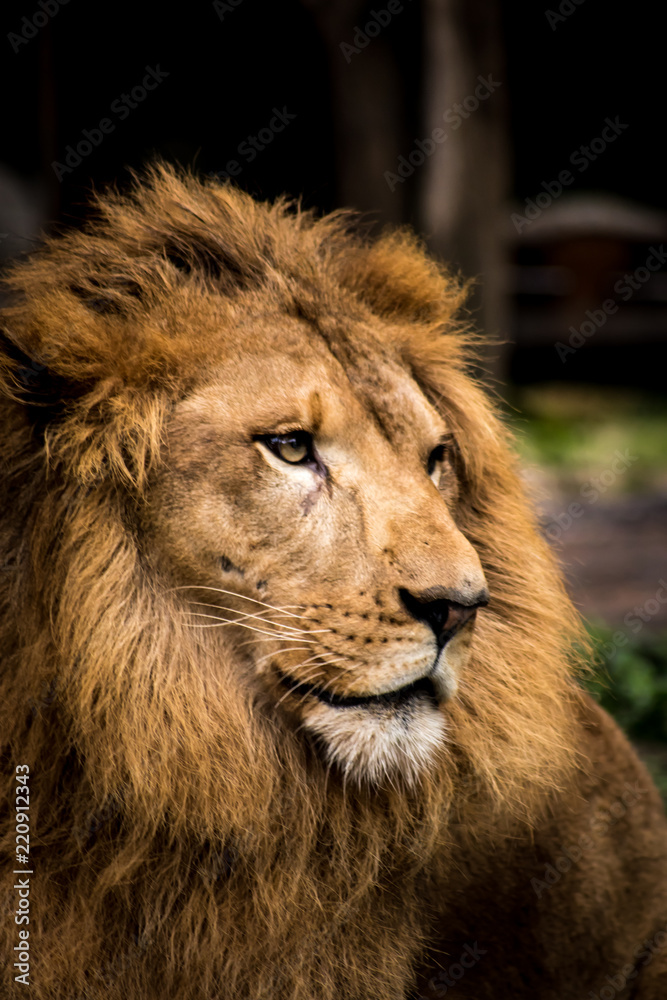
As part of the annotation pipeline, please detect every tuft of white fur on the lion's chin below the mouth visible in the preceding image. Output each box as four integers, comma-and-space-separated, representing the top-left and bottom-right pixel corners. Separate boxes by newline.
304, 698, 447, 787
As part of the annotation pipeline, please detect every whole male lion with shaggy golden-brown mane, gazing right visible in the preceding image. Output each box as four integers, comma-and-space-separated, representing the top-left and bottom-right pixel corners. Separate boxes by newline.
0, 164, 667, 1000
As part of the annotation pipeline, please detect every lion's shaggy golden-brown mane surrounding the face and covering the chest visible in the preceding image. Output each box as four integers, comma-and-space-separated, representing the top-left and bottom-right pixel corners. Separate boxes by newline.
0, 166, 579, 1000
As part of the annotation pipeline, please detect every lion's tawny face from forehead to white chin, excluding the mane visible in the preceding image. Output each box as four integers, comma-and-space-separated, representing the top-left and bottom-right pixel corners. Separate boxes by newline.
144, 286, 488, 783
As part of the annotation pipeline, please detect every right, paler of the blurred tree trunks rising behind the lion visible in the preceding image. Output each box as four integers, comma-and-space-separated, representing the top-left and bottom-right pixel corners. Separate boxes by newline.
419, 0, 510, 376
